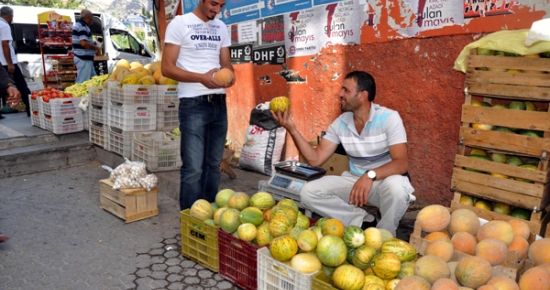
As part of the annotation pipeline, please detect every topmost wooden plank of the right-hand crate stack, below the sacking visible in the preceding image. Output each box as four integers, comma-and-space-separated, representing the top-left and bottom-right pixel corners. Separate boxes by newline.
468, 55, 550, 72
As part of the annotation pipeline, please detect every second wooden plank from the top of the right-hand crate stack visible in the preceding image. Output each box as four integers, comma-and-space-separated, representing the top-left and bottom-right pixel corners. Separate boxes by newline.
466, 70, 550, 89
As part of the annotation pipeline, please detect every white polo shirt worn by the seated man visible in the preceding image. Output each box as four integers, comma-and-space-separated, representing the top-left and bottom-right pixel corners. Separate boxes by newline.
323, 103, 407, 176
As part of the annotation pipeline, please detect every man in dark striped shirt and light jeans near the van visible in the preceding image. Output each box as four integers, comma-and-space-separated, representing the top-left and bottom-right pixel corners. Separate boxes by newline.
72, 9, 99, 83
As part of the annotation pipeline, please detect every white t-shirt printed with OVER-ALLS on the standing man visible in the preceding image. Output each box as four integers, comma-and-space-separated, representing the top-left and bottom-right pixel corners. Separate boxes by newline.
164, 13, 231, 98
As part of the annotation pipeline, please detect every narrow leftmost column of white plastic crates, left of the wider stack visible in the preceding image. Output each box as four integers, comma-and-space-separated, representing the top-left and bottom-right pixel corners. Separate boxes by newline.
88, 87, 109, 149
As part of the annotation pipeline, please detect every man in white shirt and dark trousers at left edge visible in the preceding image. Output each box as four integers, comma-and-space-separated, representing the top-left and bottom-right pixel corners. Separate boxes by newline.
0, 6, 31, 117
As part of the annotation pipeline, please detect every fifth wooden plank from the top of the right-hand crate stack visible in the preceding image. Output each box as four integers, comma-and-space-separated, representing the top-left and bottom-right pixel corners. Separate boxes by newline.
460, 127, 550, 158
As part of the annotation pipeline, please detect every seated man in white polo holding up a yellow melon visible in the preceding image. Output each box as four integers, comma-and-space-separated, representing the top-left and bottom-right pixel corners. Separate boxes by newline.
273, 71, 414, 235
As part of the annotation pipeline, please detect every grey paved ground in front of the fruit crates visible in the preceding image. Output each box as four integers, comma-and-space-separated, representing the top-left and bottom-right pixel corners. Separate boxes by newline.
0, 162, 267, 290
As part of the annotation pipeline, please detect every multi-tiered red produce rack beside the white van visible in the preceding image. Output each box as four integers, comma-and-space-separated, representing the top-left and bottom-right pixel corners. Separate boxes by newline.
38, 11, 76, 89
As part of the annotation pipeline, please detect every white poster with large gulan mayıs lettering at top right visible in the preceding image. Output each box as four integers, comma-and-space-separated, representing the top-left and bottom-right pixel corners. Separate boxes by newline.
416, 0, 464, 31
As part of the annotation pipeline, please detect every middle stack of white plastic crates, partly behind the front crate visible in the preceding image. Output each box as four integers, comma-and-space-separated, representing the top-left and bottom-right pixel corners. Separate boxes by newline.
107, 81, 157, 157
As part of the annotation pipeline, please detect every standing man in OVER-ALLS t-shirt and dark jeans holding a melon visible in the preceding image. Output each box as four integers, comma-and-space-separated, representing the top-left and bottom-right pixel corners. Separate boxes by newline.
162, 0, 233, 210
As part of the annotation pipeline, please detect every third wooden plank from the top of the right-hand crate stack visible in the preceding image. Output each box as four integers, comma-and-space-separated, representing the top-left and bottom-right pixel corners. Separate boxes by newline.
466, 82, 550, 101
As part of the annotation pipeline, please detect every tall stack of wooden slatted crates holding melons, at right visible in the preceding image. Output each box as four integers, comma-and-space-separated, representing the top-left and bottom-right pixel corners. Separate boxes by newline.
452, 51, 550, 236
